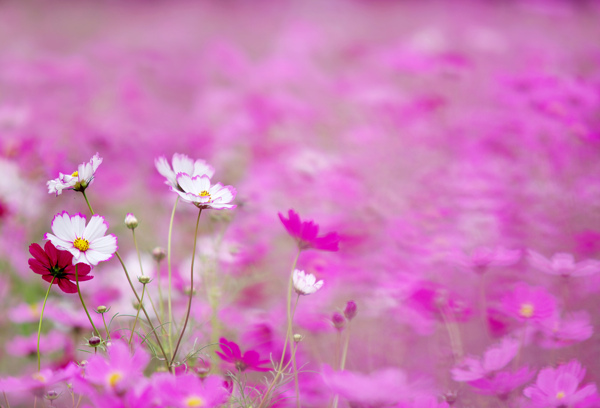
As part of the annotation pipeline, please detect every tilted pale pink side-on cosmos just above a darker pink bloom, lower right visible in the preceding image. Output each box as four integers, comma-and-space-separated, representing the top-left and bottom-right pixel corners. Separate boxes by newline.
452, 337, 519, 382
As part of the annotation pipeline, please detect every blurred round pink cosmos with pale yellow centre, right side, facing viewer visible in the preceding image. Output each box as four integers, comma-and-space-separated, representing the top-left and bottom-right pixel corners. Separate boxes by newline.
502, 283, 556, 322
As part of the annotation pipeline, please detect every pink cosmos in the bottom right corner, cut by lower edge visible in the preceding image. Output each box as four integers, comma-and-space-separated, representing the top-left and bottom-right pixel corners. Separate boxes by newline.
523, 360, 596, 408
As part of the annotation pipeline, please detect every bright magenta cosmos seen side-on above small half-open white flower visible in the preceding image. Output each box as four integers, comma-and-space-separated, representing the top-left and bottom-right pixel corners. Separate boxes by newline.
279, 210, 340, 251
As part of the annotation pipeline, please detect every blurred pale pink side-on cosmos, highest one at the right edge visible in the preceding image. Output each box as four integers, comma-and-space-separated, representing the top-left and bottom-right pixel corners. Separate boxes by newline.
529, 250, 600, 277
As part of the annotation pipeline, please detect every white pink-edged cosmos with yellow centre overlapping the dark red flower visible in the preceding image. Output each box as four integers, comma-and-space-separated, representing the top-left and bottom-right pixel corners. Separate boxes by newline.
44, 211, 117, 265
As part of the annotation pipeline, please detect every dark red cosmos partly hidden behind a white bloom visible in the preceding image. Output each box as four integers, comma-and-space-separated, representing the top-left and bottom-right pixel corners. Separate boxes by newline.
29, 241, 93, 293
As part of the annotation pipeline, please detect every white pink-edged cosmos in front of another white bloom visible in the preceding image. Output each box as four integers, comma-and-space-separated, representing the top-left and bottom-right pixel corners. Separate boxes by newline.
171, 173, 236, 210
